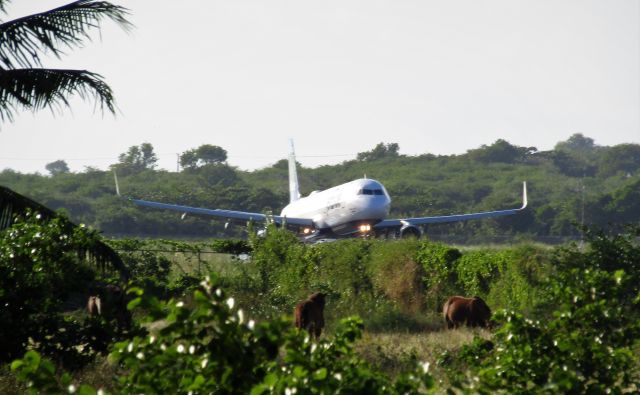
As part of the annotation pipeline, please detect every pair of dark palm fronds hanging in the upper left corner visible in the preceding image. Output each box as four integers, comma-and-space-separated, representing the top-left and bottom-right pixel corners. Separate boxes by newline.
0, 0, 131, 121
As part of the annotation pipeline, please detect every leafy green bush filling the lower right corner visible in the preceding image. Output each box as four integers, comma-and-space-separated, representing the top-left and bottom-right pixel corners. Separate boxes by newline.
444, 229, 640, 393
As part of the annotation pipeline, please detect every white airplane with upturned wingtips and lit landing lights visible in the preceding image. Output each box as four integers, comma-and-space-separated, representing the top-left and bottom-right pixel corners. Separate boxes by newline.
114, 141, 527, 242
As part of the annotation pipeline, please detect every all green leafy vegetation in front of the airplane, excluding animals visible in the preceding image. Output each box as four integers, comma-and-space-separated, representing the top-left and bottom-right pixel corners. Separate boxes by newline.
0, 197, 640, 394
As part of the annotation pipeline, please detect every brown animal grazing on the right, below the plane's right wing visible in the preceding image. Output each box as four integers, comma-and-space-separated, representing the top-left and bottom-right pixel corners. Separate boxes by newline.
442, 296, 491, 329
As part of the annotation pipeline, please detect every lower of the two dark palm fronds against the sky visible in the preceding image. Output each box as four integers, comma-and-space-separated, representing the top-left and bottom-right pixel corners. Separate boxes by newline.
0, 69, 115, 121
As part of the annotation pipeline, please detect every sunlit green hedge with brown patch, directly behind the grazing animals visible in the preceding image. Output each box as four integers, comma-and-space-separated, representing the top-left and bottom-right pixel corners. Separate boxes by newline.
231, 227, 550, 330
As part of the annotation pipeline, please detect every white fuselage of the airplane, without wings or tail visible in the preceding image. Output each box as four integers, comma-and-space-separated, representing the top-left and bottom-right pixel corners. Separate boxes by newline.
280, 178, 391, 230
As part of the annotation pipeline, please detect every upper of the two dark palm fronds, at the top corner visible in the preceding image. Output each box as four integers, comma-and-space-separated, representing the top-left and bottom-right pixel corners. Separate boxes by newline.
0, 0, 132, 69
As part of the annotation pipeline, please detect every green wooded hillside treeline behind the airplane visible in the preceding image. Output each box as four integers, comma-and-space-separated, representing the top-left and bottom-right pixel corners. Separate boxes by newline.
0, 134, 640, 241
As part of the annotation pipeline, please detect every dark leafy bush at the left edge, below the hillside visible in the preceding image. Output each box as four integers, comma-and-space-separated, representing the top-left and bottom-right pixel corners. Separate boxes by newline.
0, 212, 97, 361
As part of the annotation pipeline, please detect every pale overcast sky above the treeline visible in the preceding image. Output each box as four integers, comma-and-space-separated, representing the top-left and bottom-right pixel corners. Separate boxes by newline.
0, 0, 640, 173
